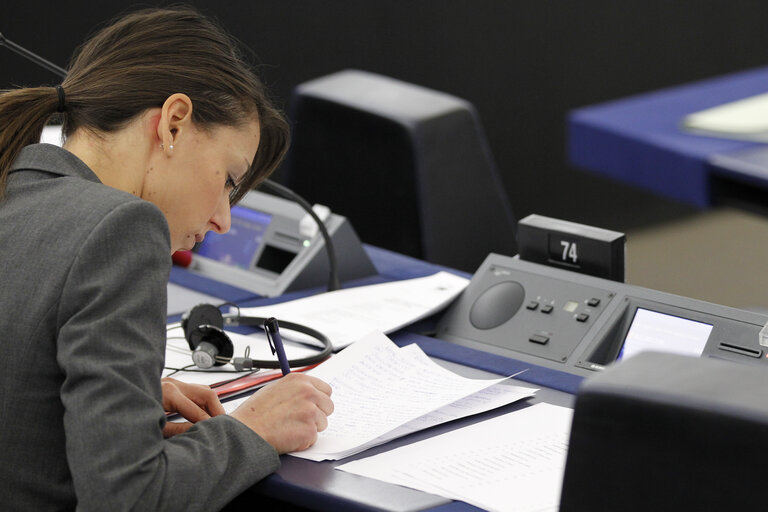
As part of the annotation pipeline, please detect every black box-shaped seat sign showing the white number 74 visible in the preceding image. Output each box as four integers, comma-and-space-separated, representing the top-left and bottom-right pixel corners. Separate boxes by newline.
517, 214, 627, 282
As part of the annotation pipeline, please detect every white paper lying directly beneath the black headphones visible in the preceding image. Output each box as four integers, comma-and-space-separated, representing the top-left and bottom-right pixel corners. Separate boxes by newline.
163, 325, 317, 386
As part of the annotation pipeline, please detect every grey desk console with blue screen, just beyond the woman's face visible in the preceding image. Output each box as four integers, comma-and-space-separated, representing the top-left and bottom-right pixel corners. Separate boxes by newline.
188, 191, 377, 297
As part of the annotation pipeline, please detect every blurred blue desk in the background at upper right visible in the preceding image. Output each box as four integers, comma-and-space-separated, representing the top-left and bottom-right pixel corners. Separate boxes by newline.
567, 67, 768, 208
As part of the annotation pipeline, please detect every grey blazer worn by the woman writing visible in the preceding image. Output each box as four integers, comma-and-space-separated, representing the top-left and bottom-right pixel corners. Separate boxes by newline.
0, 144, 279, 512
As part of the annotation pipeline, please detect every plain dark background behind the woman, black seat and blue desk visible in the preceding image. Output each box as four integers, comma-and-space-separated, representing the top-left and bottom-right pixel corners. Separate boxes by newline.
6, 0, 768, 242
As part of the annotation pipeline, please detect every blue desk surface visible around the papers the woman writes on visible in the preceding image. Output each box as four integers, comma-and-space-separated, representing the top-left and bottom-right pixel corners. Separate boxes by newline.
169, 246, 581, 512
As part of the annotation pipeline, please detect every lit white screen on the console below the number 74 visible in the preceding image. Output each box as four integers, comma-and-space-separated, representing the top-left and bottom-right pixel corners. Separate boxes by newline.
617, 308, 712, 359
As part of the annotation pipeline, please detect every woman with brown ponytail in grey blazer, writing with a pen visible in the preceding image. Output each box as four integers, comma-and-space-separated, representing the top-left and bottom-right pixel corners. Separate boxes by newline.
0, 5, 333, 510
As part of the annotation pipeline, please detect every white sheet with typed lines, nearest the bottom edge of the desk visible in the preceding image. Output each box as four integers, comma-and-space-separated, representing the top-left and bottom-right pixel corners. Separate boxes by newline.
336, 403, 573, 512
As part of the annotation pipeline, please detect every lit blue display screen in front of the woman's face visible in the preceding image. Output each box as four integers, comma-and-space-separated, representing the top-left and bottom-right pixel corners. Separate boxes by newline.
195, 206, 272, 269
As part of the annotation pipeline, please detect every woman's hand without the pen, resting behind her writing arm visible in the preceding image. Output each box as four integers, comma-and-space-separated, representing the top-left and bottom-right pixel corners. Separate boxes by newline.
162, 378, 224, 437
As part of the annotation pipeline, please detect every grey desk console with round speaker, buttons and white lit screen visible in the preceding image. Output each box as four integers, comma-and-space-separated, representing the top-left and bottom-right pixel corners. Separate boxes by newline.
436, 254, 768, 375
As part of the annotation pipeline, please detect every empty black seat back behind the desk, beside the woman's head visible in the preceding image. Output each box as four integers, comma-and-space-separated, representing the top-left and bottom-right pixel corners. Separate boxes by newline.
282, 70, 515, 271
